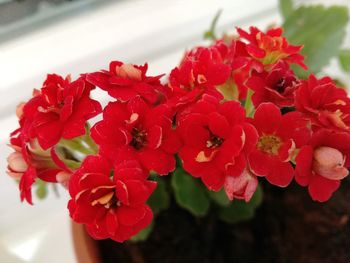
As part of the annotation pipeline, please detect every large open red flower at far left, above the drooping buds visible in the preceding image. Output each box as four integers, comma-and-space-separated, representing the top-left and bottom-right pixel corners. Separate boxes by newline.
23, 75, 101, 150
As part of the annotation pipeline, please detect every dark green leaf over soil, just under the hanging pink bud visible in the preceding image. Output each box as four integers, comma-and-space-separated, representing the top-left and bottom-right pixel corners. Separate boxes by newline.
219, 186, 262, 224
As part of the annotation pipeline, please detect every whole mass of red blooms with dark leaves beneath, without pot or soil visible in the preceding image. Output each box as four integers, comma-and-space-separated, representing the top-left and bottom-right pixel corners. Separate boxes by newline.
8, 4, 350, 242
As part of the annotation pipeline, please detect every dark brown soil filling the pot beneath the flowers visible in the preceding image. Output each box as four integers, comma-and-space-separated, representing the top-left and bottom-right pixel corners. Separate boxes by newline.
99, 180, 350, 263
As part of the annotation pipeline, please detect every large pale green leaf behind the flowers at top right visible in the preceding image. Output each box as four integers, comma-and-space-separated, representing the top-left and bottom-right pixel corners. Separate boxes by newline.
283, 5, 349, 78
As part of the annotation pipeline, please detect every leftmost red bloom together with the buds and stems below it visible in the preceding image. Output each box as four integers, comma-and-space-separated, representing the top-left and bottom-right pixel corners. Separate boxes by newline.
8, 75, 101, 204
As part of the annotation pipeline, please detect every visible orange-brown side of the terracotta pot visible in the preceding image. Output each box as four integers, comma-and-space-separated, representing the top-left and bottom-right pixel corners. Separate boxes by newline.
72, 222, 101, 263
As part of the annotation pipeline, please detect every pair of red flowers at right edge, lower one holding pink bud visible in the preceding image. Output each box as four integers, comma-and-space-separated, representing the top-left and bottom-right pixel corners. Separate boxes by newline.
295, 75, 350, 202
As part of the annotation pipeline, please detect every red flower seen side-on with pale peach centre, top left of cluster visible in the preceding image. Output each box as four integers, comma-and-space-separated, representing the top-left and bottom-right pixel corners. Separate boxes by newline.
86, 61, 169, 104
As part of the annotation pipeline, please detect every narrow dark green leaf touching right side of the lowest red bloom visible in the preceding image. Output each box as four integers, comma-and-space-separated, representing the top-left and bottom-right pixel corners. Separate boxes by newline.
147, 176, 170, 215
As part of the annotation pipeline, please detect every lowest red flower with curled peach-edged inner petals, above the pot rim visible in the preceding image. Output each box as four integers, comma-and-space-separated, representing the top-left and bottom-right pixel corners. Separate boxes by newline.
68, 156, 157, 242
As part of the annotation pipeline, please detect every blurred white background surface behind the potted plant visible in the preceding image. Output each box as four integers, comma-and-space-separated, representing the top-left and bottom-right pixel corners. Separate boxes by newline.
0, 0, 350, 263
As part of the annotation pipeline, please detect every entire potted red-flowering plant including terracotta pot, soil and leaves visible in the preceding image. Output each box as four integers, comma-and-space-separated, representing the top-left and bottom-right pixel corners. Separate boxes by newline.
4, 1, 350, 262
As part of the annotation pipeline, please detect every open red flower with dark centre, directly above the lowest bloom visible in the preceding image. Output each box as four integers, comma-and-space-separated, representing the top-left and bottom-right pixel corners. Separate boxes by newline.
91, 97, 180, 175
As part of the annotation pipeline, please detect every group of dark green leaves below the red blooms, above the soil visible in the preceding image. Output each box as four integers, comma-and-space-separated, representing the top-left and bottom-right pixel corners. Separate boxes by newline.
131, 161, 263, 241
